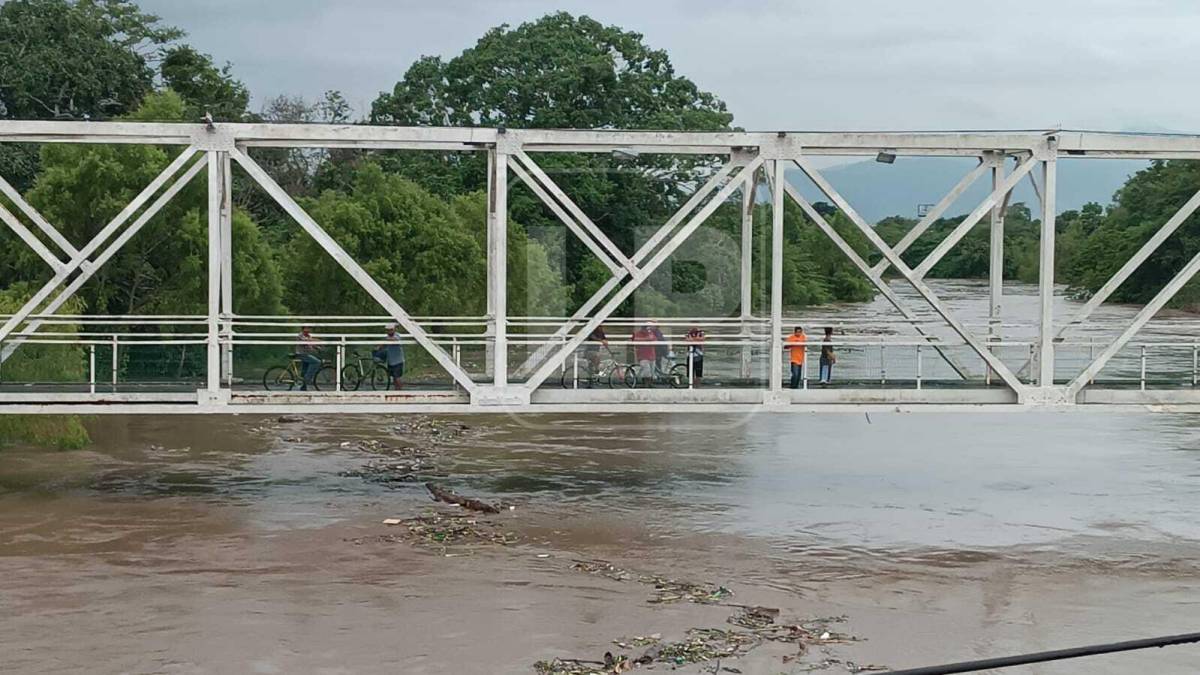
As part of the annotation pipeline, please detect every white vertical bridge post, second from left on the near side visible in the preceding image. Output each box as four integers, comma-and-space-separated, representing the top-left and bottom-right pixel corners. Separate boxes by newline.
487, 150, 509, 388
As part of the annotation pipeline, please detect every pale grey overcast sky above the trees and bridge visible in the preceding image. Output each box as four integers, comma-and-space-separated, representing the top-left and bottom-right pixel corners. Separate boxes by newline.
139, 0, 1200, 132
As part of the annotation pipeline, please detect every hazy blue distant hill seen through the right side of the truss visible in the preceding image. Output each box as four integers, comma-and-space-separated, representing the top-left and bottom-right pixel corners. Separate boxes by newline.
787, 157, 1148, 222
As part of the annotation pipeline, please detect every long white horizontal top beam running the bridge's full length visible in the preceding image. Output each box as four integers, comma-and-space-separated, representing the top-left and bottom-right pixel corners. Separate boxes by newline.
0, 120, 1200, 157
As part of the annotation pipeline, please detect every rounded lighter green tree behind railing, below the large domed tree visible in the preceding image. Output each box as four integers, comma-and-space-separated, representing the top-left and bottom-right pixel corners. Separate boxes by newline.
284, 163, 562, 315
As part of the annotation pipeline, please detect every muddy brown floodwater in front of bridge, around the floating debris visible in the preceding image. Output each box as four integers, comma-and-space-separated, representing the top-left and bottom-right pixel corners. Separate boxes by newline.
0, 281, 1200, 674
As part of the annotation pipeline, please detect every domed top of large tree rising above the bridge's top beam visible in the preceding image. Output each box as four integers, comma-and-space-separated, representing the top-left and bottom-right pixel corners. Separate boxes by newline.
371, 12, 733, 130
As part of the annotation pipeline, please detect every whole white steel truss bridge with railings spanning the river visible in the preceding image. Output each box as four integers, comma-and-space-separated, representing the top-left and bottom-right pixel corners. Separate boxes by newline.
0, 121, 1200, 413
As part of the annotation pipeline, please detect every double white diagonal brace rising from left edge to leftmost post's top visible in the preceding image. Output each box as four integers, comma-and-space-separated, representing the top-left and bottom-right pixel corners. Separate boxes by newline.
0, 147, 205, 363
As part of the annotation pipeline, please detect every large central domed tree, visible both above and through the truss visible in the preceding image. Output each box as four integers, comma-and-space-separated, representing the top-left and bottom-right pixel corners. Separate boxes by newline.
371, 12, 733, 300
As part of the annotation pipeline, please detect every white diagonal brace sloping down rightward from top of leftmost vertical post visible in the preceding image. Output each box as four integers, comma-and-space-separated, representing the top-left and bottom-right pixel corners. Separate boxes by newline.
229, 148, 478, 394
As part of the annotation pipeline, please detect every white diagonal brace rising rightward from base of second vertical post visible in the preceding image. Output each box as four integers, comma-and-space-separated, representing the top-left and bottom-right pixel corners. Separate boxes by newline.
524, 155, 763, 392
